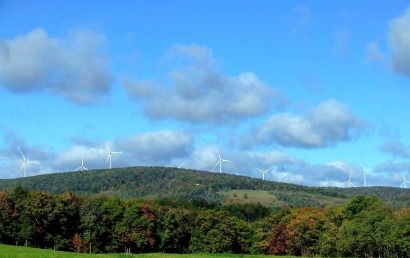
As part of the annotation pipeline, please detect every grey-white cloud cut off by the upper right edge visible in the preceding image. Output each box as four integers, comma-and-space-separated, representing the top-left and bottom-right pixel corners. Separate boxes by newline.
389, 8, 410, 76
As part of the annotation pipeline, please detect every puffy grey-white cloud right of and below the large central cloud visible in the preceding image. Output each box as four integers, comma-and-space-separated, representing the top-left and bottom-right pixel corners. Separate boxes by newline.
252, 99, 364, 148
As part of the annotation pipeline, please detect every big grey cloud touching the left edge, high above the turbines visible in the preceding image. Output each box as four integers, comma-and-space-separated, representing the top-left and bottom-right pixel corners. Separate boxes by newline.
0, 28, 112, 104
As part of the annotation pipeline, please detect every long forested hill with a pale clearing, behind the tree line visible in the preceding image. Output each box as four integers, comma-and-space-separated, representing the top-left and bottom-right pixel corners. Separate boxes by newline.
0, 167, 410, 208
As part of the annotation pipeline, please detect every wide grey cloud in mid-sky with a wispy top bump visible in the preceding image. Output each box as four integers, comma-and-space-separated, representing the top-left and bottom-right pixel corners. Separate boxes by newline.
124, 45, 286, 123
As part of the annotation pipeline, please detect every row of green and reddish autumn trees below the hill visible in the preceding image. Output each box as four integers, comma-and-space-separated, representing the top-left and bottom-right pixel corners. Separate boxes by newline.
0, 187, 410, 257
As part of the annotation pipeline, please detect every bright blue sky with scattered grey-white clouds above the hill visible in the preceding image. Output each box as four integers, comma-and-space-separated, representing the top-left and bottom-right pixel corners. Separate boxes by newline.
0, 0, 410, 187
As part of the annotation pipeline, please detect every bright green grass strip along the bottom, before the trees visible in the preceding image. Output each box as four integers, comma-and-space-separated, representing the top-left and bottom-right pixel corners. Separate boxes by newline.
0, 244, 274, 258
